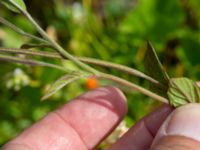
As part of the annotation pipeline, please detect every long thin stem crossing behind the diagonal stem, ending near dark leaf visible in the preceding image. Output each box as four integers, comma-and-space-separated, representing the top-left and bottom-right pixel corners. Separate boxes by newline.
0, 48, 162, 86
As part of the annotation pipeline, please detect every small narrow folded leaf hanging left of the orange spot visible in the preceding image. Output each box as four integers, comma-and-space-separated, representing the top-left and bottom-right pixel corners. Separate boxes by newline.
42, 72, 83, 101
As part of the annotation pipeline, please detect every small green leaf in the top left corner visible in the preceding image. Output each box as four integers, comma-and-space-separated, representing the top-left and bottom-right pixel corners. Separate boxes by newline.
0, 0, 26, 13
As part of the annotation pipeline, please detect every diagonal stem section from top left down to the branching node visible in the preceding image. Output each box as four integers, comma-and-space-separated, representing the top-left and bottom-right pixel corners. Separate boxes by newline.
9, 0, 99, 75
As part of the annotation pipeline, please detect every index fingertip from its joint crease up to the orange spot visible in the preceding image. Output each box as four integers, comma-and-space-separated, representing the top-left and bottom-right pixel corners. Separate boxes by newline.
56, 86, 127, 149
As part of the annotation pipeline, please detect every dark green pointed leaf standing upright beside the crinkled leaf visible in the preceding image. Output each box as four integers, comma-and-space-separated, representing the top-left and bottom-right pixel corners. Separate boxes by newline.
144, 42, 169, 98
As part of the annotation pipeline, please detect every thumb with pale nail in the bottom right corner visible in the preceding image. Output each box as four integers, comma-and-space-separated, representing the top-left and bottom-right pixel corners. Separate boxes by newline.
151, 104, 200, 150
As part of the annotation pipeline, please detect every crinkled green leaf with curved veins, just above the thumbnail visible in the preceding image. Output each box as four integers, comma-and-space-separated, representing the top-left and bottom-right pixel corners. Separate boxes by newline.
167, 77, 200, 107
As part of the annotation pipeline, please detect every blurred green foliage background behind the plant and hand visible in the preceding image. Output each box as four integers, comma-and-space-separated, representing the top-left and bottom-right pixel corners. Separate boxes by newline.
0, 0, 200, 146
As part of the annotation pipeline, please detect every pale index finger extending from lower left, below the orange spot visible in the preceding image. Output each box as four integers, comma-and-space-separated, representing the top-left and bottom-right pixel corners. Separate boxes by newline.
4, 87, 127, 150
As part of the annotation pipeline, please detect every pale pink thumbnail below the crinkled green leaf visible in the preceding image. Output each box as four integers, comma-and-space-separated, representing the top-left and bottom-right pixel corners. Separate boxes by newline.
153, 104, 200, 145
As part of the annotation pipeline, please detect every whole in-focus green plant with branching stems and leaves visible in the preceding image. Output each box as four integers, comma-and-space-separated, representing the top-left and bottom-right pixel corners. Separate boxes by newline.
0, 0, 200, 107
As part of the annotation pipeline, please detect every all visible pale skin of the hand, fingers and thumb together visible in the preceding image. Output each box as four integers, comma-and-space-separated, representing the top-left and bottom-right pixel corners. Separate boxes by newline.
3, 87, 200, 150
